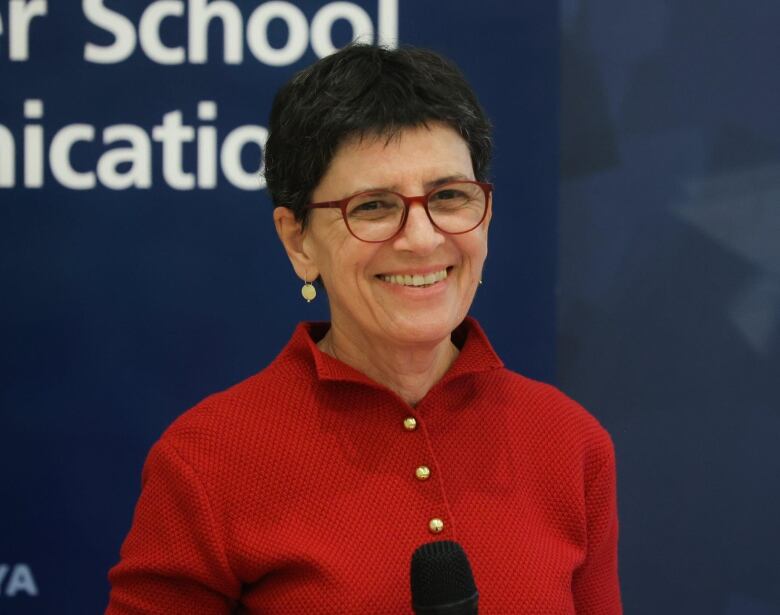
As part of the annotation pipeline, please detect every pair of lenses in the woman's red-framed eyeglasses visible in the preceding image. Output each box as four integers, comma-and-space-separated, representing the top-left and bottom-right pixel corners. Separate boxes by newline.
346, 182, 486, 241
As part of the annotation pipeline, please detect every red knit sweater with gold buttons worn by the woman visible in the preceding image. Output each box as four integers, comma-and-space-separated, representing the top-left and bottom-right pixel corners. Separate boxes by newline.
107, 319, 621, 615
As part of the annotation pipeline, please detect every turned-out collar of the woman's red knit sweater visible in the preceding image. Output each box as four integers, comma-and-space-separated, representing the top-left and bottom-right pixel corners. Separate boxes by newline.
290, 316, 504, 386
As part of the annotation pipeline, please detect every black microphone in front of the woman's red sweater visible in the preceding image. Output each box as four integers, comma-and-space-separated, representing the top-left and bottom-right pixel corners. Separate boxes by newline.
410, 540, 479, 615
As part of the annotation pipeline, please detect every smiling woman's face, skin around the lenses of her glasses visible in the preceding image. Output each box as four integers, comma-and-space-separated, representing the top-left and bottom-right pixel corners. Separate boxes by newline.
303, 123, 490, 345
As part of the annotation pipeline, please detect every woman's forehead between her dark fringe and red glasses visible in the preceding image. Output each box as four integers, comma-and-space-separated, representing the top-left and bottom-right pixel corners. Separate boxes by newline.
315, 122, 474, 198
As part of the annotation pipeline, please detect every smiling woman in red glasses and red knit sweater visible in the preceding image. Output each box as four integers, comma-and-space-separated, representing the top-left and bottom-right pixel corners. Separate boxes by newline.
108, 46, 621, 615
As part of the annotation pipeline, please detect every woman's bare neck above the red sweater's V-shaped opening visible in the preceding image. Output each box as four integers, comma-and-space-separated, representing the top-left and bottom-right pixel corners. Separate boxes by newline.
317, 323, 458, 406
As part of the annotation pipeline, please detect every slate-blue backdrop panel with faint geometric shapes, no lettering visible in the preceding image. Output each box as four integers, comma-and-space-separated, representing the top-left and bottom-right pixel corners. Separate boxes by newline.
557, 0, 780, 615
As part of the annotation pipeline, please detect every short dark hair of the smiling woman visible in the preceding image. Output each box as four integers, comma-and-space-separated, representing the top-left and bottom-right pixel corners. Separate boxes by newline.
264, 44, 493, 220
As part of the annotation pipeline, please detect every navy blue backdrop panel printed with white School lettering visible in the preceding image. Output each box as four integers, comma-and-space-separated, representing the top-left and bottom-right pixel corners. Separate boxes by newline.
0, 0, 559, 615
